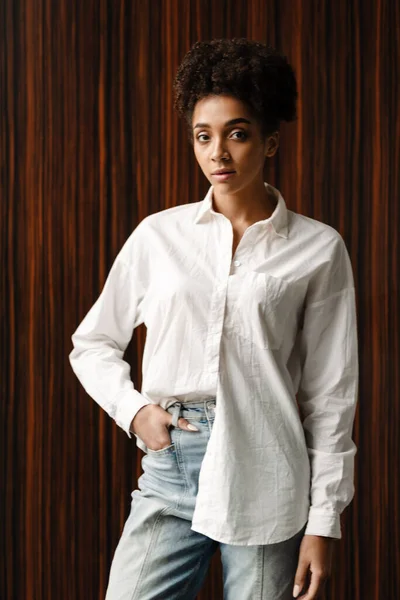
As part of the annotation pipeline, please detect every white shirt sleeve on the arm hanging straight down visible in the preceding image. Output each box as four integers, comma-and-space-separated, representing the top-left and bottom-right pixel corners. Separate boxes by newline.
297, 234, 358, 539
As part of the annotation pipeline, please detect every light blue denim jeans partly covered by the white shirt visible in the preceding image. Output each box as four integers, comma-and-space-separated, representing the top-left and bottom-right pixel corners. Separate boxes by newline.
105, 398, 305, 600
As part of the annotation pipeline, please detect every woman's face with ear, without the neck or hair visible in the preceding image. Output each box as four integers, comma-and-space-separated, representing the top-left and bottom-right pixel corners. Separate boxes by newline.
192, 94, 279, 193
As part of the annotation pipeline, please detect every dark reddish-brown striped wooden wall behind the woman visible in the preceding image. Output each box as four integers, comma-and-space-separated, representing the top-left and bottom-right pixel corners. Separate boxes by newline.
0, 0, 400, 600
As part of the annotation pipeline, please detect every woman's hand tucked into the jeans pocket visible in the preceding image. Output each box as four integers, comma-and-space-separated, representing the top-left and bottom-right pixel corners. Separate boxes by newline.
130, 404, 198, 450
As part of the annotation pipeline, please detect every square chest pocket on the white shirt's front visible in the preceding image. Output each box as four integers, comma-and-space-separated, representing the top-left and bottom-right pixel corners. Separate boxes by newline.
225, 271, 295, 350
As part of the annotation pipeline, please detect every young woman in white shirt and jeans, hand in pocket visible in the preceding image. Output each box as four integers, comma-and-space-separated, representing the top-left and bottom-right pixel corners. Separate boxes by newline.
70, 38, 358, 600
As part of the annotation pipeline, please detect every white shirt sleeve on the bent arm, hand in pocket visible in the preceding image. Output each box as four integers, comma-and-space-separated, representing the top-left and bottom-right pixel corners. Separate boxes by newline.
69, 223, 150, 438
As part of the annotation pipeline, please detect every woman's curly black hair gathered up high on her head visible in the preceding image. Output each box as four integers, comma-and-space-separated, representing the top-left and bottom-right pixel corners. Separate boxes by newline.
173, 38, 297, 145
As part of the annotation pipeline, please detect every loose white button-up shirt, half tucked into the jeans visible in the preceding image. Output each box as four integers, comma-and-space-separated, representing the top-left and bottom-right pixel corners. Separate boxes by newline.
69, 183, 358, 545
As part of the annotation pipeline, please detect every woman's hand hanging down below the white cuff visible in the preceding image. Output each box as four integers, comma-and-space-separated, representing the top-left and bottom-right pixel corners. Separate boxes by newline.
293, 535, 335, 600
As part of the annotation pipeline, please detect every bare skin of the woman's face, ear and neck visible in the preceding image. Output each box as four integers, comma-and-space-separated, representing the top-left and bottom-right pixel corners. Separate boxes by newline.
192, 94, 279, 227
